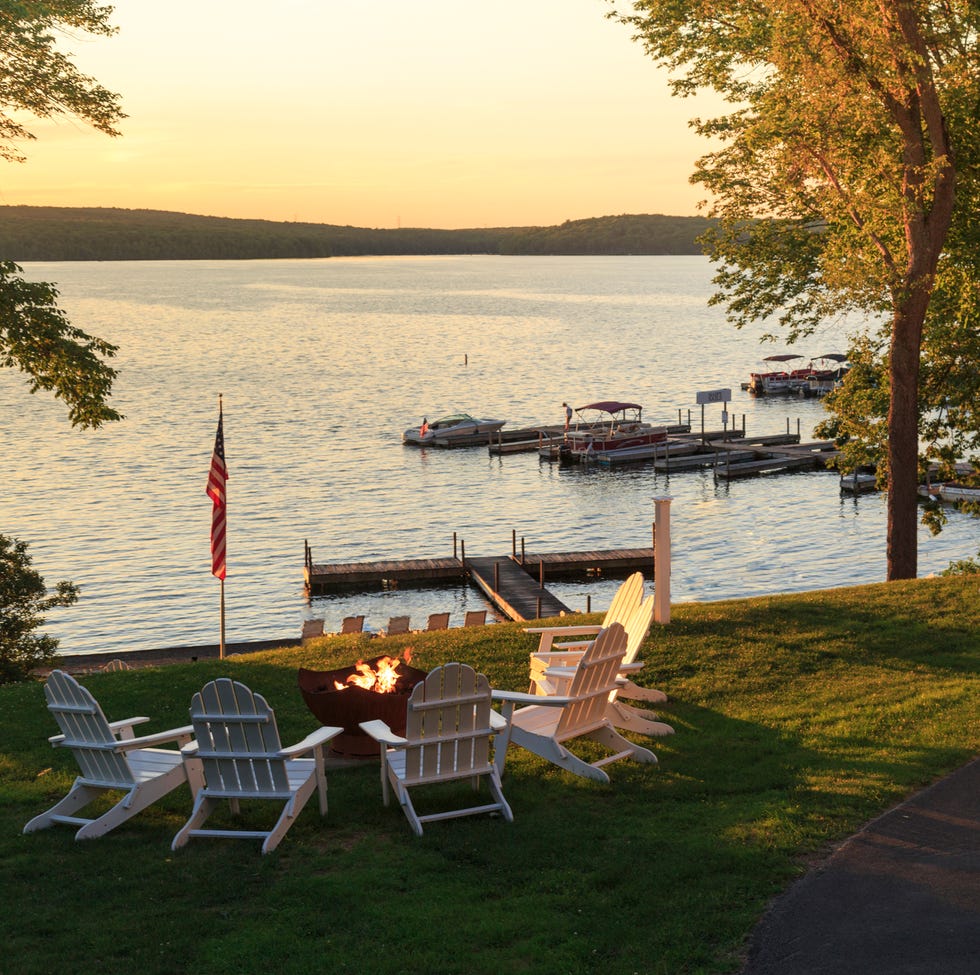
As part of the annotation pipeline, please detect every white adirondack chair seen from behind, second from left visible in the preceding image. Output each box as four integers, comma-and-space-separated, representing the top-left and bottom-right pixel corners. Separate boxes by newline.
171, 677, 343, 853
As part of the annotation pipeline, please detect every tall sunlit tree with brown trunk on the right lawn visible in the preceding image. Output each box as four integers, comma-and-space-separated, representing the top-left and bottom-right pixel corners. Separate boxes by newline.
612, 0, 980, 579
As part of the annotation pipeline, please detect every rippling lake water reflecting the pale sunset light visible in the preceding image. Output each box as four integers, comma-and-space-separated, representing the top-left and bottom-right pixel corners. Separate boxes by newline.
0, 256, 980, 653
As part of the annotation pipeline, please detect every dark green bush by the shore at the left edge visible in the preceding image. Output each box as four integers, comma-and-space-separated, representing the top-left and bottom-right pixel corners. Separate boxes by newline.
0, 535, 78, 684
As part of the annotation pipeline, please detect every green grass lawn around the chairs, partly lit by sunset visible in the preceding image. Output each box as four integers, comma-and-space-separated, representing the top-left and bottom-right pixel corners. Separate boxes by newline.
0, 576, 980, 975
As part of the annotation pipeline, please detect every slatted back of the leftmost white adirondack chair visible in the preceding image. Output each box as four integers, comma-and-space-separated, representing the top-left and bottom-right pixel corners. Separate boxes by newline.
44, 670, 136, 789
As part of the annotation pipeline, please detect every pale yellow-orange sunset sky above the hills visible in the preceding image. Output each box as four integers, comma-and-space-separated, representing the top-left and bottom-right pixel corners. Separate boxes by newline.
0, 0, 718, 228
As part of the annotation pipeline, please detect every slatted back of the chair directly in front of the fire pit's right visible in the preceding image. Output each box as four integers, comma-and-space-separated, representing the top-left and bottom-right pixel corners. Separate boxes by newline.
405, 663, 492, 784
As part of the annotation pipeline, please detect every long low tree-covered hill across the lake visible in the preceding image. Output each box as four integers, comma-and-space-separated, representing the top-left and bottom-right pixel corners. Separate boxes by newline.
0, 206, 710, 262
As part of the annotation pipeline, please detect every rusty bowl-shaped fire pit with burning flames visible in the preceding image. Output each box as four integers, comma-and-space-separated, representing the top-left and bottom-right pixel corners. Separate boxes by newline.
299, 654, 427, 758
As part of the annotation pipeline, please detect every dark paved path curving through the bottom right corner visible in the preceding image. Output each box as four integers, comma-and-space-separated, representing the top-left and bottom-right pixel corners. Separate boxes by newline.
742, 758, 980, 975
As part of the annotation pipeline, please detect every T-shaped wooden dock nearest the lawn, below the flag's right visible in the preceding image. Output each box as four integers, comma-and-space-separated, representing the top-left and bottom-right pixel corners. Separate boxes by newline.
304, 544, 653, 621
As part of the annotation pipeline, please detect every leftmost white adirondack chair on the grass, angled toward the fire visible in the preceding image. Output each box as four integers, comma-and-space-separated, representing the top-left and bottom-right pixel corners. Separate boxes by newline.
24, 670, 200, 840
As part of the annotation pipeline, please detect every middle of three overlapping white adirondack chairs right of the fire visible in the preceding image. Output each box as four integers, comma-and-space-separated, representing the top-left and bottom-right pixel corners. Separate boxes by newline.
530, 596, 674, 738
